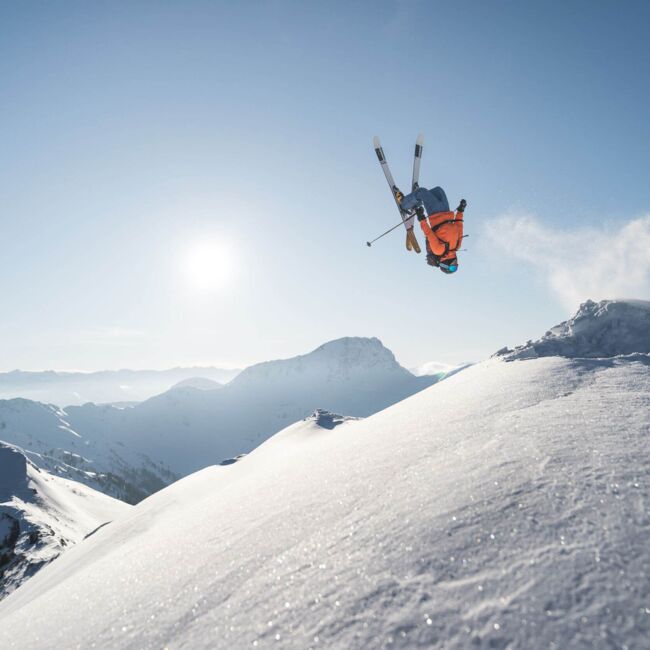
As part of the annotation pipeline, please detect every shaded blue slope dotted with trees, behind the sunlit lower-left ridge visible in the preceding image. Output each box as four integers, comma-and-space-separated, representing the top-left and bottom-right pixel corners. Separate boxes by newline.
0, 399, 176, 503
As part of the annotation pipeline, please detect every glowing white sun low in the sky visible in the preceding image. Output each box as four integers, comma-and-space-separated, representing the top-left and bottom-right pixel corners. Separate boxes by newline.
183, 241, 234, 292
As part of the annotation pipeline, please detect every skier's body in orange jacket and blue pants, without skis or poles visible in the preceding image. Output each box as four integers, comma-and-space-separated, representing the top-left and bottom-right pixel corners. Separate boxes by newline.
397, 187, 467, 273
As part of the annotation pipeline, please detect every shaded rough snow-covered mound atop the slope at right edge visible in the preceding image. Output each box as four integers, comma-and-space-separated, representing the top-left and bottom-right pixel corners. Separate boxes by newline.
495, 300, 650, 361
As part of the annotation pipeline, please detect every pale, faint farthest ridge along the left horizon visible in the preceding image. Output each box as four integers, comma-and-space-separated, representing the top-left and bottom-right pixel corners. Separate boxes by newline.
0, 368, 240, 406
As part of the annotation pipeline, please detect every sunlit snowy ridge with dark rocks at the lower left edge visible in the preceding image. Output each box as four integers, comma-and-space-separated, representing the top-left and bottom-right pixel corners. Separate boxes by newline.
0, 444, 130, 598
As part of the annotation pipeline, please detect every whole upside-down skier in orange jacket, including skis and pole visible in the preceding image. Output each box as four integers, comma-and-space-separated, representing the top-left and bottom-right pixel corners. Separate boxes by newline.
367, 134, 467, 273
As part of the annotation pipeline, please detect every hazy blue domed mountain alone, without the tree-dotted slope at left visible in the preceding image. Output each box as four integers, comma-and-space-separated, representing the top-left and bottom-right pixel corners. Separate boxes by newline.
66, 338, 438, 475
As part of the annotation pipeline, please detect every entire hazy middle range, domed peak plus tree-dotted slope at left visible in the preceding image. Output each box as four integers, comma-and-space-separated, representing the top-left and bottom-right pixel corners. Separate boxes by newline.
0, 338, 438, 494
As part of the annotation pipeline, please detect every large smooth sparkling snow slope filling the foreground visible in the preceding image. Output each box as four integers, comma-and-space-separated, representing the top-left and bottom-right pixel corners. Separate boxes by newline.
0, 356, 650, 650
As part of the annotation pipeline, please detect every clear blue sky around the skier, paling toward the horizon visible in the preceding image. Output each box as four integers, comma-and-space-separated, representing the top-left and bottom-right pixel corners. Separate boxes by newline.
0, 1, 650, 370
